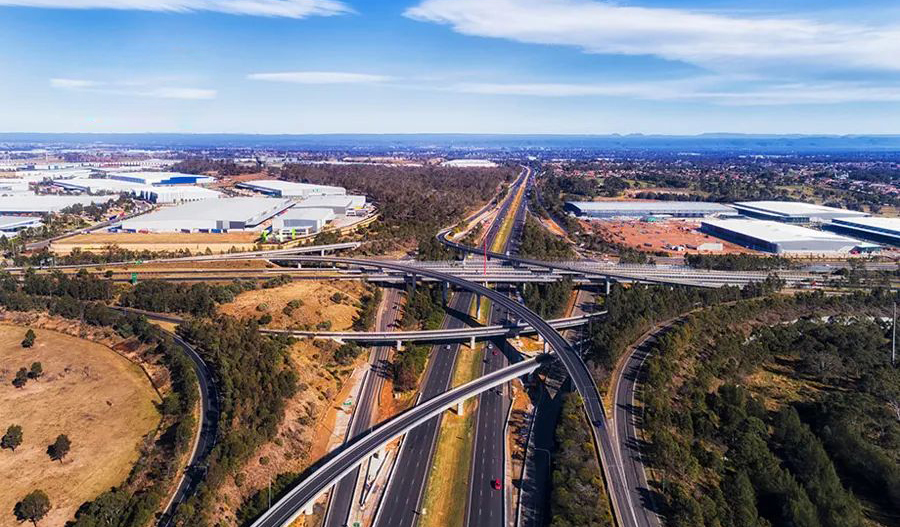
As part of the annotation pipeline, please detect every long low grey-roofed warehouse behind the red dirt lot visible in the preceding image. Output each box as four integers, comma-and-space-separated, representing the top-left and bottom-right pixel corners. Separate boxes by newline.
565, 201, 735, 219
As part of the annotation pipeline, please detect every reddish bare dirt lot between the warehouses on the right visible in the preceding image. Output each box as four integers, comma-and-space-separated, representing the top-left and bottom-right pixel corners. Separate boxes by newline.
588, 220, 755, 255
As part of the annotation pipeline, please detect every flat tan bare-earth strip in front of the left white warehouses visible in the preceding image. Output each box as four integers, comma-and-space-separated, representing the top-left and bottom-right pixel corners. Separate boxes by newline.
50, 232, 259, 254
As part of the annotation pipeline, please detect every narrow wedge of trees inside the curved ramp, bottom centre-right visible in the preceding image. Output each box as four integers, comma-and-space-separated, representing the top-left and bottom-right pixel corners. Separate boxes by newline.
550, 393, 613, 527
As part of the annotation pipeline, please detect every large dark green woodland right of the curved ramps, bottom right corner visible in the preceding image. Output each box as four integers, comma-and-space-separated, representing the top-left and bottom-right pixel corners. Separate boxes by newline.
641, 291, 900, 527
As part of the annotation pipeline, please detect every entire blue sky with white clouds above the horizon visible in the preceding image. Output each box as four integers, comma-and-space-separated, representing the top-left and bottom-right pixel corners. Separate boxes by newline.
0, 0, 900, 134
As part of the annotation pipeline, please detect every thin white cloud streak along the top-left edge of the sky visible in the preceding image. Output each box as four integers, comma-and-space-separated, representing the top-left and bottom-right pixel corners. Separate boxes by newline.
0, 0, 353, 18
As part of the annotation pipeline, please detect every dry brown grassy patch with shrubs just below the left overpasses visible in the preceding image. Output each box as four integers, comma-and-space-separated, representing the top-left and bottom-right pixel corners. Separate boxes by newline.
219, 280, 365, 331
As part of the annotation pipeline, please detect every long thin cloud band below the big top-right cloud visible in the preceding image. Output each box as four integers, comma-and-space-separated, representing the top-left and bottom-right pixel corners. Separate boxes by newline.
449, 77, 900, 106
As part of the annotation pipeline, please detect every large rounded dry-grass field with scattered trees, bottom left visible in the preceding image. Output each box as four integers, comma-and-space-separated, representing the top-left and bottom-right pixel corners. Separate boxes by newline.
0, 325, 159, 527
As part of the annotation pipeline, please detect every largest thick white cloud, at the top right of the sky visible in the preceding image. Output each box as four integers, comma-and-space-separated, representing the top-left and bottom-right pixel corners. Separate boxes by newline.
405, 0, 900, 72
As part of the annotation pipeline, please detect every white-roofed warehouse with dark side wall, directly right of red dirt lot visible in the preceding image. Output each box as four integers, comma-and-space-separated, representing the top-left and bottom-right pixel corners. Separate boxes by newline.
700, 219, 868, 256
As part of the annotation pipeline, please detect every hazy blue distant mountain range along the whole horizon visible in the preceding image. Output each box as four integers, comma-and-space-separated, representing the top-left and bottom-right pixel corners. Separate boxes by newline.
0, 133, 900, 155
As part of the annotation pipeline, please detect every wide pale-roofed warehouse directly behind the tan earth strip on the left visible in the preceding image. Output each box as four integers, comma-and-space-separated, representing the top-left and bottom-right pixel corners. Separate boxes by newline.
120, 198, 294, 232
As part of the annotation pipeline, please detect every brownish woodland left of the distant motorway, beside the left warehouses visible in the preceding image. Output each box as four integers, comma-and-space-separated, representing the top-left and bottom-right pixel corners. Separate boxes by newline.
281, 165, 517, 251
